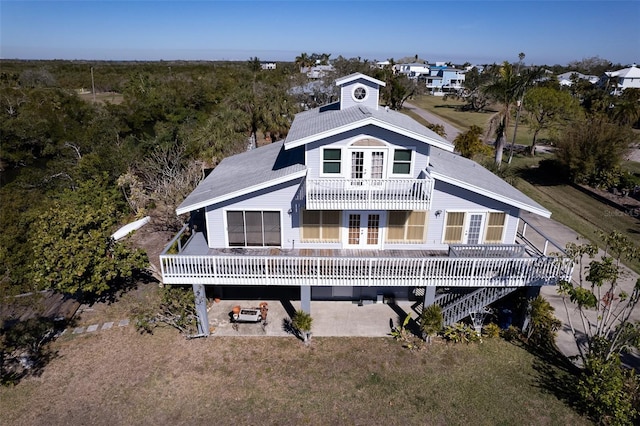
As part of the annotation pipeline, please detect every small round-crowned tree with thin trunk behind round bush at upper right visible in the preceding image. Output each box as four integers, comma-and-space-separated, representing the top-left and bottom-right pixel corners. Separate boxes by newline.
523, 87, 580, 155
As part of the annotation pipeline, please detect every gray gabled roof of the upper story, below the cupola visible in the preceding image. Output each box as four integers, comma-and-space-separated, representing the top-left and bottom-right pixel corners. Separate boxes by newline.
285, 103, 453, 148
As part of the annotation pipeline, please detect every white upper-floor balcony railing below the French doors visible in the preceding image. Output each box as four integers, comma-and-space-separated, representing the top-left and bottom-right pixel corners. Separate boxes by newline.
303, 178, 434, 210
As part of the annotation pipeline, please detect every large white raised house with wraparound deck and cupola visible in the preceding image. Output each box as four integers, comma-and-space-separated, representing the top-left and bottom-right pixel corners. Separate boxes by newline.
160, 74, 571, 334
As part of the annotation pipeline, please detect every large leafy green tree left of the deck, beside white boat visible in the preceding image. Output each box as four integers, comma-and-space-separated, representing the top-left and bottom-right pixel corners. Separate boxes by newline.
31, 176, 148, 298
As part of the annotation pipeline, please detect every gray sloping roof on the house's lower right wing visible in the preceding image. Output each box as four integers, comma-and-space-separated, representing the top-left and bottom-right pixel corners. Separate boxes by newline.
427, 147, 551, 217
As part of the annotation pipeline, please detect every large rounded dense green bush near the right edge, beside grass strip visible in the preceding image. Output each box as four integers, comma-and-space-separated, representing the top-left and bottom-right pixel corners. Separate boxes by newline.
556, 113, 634, 188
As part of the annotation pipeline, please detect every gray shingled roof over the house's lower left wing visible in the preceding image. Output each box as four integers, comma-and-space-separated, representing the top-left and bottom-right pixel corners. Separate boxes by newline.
176, 141, 307, 214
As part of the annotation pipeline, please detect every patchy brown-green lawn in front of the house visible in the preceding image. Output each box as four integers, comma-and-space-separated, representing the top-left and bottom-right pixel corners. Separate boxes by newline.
0, 327, 591, 425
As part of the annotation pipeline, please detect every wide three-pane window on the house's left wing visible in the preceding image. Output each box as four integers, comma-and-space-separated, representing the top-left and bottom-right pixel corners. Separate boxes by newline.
227, 211, 281, 247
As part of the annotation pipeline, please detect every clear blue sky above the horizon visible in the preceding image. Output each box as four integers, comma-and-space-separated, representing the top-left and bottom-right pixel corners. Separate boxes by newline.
0, 0, 640, 65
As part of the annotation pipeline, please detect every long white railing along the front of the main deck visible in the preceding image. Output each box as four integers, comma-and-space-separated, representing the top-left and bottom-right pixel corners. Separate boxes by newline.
160, 254, 572, 287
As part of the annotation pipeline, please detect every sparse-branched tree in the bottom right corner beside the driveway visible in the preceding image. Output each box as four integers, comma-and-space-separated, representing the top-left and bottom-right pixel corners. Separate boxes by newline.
558, 232, 640, 425
